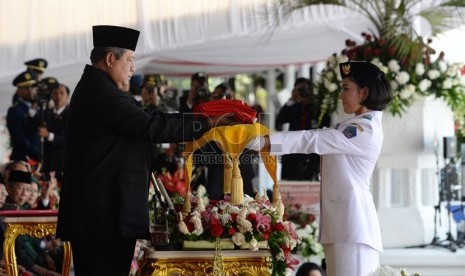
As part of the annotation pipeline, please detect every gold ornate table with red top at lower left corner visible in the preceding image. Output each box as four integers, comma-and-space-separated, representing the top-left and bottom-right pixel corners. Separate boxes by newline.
0, 211, 72, 276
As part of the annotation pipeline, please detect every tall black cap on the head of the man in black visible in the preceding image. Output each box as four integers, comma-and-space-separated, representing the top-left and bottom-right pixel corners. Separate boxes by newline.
92, 25, 140, 51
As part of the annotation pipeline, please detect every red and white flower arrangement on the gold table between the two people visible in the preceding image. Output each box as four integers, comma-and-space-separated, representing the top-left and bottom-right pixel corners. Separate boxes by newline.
171, 186, 301, 275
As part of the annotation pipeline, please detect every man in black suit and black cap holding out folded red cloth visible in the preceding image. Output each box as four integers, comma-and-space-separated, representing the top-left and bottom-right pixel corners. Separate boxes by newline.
57, 26, 230, 276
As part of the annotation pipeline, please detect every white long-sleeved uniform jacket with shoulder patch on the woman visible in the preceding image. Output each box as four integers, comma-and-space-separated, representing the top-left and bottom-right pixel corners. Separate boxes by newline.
270, 111, 383, 251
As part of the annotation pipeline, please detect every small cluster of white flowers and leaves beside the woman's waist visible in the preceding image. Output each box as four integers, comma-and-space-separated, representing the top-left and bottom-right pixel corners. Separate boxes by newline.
284, 204, 323, 261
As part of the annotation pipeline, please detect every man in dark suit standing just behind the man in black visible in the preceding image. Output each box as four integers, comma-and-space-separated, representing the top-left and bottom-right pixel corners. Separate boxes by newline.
38, 82, 69, 182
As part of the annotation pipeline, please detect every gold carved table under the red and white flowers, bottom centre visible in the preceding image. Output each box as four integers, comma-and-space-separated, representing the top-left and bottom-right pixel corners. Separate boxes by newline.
137, 248, 271, 276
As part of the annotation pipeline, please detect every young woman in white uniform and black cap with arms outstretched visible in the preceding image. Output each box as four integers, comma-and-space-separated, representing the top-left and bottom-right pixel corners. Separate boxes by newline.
247, 62, 392, 276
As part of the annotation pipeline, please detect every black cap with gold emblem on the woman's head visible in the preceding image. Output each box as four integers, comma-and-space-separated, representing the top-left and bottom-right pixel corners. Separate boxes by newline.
339, 61, 384, 80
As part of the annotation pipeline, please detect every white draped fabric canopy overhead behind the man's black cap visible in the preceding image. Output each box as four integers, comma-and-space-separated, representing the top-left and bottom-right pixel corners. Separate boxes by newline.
0, 0, 369, 111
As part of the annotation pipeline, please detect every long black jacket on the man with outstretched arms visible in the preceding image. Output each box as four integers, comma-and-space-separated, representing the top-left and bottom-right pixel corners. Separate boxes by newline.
57, 65, 208, 241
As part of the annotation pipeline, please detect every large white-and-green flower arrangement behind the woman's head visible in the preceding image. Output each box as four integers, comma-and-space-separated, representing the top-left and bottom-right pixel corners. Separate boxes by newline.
316, 33, 465, 119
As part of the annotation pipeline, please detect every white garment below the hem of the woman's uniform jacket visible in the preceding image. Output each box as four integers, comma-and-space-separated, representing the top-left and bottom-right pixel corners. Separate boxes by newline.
323, 243, 379, 276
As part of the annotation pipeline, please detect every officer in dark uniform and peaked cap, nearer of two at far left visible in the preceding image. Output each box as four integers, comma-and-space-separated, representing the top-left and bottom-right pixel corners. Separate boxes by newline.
6, 71, 40, 161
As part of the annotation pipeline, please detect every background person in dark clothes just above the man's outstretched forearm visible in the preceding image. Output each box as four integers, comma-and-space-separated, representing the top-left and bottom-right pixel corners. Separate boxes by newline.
179, 72, 210, 113
